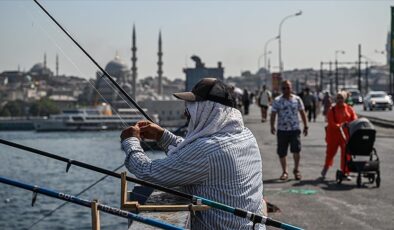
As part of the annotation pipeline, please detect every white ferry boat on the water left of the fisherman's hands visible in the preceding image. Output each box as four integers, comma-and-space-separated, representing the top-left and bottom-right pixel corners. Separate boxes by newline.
34, 104, 154, 132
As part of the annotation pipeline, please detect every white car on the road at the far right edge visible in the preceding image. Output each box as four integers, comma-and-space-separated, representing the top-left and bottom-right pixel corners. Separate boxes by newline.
364, 91, 393, 111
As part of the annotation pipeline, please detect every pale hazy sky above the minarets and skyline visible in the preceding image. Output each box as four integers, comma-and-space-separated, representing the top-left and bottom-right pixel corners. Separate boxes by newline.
0, 0, 394, 79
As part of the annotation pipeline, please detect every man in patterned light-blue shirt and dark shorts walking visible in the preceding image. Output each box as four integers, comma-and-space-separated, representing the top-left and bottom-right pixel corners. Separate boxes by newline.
271, 80, 308, 180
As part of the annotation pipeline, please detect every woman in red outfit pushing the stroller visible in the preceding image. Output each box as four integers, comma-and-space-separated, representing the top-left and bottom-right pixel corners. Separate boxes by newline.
321, 91, 357, 180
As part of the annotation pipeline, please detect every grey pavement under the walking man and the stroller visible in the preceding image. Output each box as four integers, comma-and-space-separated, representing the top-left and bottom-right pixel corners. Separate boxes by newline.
244, 105, 394, 230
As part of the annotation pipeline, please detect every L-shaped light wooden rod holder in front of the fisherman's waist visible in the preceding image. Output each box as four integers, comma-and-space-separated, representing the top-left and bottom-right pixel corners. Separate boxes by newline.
120, 172, 209, 214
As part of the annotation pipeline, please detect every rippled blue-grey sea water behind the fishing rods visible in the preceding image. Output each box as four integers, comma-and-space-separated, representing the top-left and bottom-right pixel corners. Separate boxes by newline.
0, 131, 164, 230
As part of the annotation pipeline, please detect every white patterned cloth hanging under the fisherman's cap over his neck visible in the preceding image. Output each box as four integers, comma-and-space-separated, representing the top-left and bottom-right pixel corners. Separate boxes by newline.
168, 101, 244, 155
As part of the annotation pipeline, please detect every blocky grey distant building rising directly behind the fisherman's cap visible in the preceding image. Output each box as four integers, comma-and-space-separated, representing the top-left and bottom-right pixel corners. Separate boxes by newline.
183, 56, 224, 91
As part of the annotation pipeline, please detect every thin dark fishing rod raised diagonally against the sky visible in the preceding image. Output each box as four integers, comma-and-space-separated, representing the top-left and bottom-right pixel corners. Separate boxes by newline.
33, 0, 155, 123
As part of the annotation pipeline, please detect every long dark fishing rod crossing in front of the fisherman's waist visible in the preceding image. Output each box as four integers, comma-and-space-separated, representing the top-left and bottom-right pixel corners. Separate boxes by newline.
0, 139, 302, 230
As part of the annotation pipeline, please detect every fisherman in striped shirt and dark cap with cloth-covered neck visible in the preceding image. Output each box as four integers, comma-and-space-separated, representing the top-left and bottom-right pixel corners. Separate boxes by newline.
121, 78, 265, 229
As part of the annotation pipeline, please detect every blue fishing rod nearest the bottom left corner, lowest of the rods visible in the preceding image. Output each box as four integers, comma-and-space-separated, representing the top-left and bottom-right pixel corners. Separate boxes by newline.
0, 176, 183, 230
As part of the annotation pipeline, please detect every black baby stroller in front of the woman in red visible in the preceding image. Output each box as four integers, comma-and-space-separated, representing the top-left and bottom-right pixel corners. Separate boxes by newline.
336, 118, 381, 187
